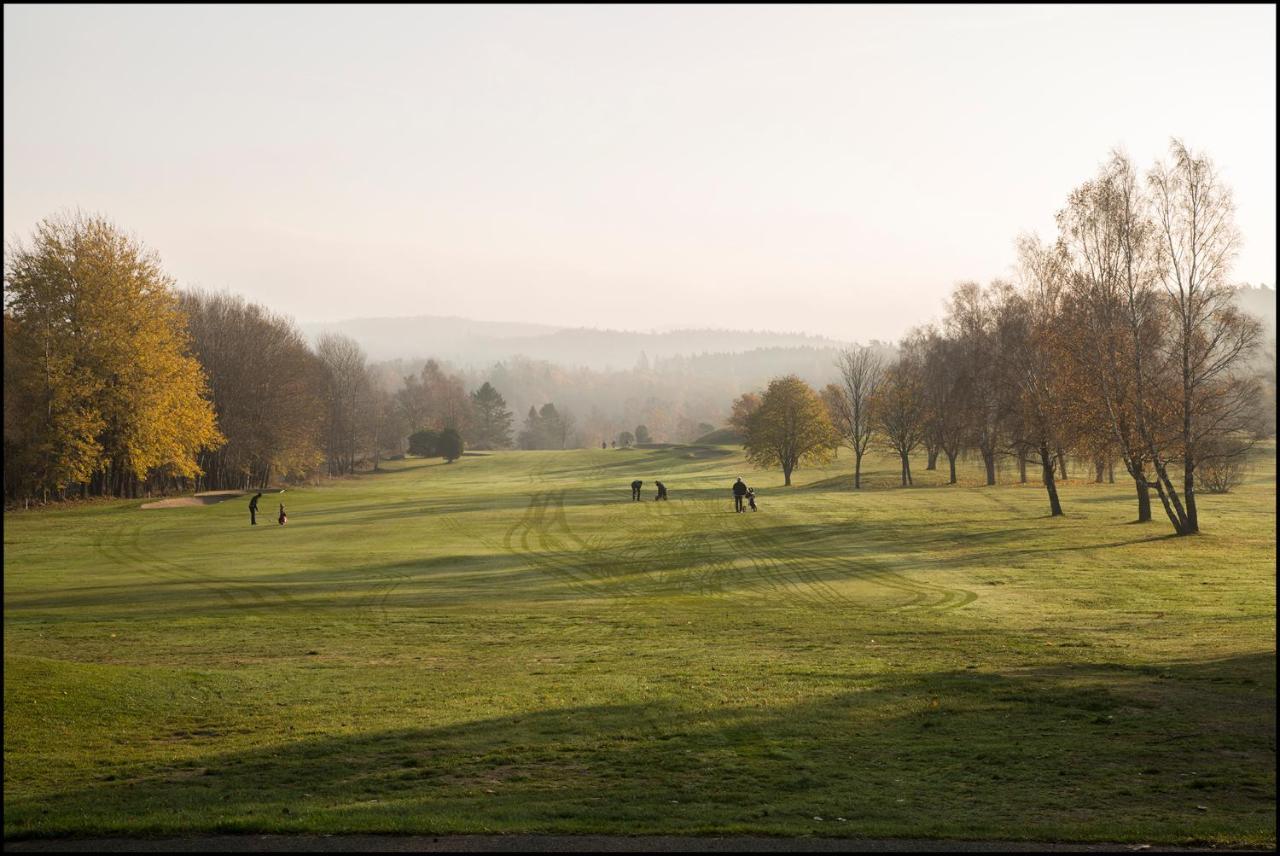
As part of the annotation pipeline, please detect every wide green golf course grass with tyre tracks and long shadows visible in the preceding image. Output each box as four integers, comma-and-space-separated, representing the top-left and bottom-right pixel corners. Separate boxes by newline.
4, 447, 1276, 844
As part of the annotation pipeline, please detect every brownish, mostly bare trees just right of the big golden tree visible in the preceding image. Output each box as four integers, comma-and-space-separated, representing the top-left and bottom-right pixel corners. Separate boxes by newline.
179, 292, 527, 487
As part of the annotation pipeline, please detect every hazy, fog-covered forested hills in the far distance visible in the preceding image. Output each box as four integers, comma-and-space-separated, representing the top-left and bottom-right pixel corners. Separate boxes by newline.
300, 285, 1276, 445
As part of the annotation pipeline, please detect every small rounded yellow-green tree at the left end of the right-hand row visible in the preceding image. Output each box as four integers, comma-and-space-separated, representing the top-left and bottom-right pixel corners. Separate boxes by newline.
742, 375, 840, 485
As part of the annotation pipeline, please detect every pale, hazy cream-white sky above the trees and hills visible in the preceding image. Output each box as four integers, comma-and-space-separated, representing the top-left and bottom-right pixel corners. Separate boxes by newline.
4, 5, 1276, 340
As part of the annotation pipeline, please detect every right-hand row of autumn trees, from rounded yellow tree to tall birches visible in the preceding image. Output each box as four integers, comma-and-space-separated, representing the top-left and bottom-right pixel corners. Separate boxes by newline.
731, 141, 1267, 535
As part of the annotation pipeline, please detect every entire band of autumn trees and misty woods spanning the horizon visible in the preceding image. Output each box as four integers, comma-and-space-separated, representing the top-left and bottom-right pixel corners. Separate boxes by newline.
4, 141, 1275, 534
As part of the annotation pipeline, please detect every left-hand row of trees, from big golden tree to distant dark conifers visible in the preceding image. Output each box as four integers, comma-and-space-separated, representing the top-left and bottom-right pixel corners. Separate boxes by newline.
4, 214, 572, 502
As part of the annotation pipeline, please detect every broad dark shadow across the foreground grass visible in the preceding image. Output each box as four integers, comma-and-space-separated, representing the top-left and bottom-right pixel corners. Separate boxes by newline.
5, 653, 1275, 841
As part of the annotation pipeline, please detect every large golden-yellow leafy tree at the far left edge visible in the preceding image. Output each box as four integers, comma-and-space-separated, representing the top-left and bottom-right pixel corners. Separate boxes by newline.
5, 212, 223, 495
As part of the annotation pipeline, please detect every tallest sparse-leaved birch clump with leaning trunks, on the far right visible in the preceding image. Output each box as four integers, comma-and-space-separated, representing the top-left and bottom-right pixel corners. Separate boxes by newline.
1059, 141, 1261, 535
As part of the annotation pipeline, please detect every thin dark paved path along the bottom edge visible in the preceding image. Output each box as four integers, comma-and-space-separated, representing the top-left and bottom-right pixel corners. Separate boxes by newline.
4, 836, 1272, 853
